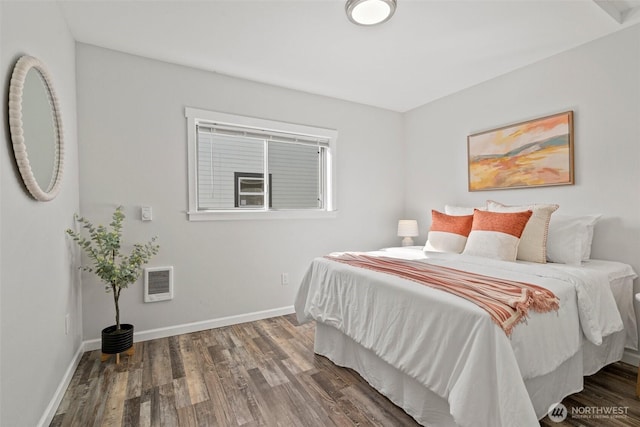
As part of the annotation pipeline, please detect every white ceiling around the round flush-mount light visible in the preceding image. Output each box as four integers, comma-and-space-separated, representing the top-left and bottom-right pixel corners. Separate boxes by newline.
58, 0, 640, 112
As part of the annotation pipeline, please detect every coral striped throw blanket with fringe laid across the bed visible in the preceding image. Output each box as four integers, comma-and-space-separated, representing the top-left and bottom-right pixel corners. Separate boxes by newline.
325, 253, 559, 335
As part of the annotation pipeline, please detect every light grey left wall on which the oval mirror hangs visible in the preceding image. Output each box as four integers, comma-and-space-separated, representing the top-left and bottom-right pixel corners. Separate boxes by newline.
0, 1, 82, 427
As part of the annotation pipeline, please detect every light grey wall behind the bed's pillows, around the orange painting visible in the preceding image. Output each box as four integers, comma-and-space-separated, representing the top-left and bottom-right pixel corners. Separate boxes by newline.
405, 25, 640, 348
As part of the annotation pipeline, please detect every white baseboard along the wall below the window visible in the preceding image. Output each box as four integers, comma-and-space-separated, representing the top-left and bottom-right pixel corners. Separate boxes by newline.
83, 306, 295, 351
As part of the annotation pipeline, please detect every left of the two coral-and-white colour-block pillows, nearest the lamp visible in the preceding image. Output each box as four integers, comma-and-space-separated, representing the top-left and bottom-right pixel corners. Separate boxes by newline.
424, 210, 473, 254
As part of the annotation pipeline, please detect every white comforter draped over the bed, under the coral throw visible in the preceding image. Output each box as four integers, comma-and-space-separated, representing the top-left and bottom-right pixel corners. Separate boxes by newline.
295, 250, 623, 427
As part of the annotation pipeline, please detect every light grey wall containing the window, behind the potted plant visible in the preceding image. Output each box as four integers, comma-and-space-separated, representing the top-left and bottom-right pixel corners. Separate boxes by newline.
77, 44, 404, 339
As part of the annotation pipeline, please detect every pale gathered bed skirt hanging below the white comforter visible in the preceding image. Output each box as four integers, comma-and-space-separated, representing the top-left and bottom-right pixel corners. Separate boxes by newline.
314, 322, 625, 427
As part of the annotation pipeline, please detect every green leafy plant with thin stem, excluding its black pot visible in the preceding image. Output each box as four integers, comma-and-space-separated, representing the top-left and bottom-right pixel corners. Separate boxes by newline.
67, 206, 160, 330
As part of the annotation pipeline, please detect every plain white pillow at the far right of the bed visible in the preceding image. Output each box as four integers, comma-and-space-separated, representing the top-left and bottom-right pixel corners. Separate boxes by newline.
547, 215, 601, 265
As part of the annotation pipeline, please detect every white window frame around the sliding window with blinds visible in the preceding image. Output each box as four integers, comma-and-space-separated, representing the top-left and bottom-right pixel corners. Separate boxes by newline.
185, 107, 338, 221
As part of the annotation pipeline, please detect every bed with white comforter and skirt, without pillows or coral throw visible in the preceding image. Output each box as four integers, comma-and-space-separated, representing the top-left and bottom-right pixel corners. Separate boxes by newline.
295, 247, 638, 427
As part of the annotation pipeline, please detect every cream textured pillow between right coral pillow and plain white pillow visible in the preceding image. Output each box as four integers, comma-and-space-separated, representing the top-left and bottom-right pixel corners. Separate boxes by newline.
487, 200, 559, 263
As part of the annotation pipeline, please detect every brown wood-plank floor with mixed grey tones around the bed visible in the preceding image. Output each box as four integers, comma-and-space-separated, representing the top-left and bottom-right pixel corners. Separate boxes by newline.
51, 315, 640, 427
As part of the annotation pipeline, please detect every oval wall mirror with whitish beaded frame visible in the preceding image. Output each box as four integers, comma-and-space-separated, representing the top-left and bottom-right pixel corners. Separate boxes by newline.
9, 56, 64, 201
